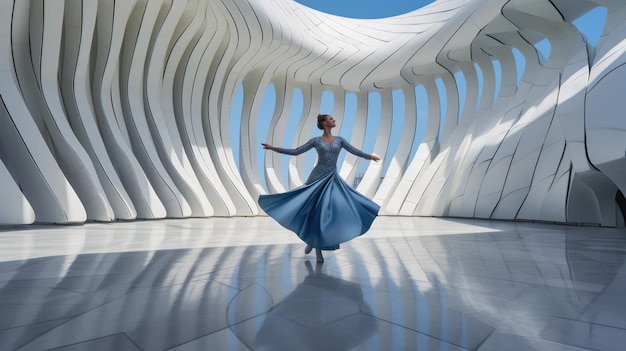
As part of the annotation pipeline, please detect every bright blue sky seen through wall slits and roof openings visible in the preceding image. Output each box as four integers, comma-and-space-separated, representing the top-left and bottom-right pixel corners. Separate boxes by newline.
230, 0, 606, 192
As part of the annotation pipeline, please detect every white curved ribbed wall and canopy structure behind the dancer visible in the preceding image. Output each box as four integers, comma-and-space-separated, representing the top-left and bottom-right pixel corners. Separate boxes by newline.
0, 0, 626, 226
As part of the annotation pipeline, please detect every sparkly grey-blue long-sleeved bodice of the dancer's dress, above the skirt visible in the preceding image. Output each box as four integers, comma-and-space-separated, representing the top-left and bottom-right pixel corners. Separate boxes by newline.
276, 136, 367, 184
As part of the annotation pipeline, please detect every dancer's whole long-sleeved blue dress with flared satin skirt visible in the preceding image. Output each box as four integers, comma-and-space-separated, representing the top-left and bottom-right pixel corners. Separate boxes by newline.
259, 136, 380, 250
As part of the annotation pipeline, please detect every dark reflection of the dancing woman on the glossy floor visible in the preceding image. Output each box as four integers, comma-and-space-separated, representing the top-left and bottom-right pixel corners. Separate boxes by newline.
253, 261, 377, 350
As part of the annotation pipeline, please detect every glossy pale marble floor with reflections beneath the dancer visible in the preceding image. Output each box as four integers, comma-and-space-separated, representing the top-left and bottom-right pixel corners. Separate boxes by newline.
0, 217, 626, 351
